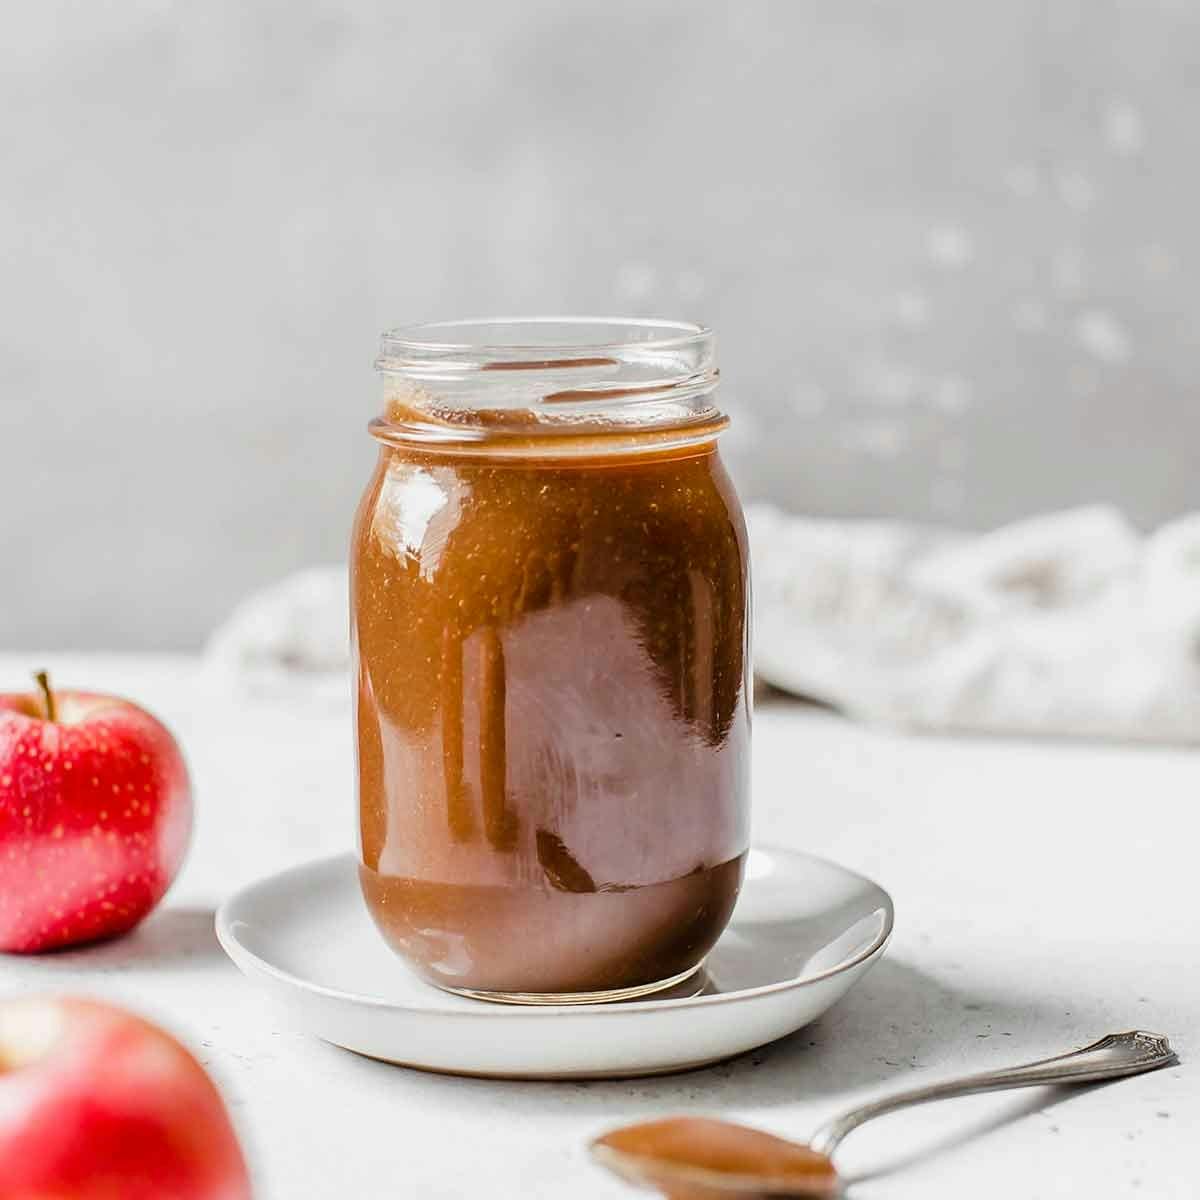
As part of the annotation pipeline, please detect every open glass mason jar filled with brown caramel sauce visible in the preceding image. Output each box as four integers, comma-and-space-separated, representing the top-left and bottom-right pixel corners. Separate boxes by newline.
352, 318, 750, 1003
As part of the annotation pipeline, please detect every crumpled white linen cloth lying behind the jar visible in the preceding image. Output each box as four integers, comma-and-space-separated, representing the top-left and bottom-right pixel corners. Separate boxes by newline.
206, 505, 1200, 743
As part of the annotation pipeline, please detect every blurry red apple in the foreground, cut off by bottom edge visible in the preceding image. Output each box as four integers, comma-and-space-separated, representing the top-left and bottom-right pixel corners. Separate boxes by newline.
0, 996, 250, 1200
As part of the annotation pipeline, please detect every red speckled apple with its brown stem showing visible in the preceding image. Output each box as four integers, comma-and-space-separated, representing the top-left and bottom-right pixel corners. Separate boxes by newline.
0, 673, 192, 952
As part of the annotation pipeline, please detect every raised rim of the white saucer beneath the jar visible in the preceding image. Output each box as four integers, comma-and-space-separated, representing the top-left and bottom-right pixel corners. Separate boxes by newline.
214, 842, 895, 1020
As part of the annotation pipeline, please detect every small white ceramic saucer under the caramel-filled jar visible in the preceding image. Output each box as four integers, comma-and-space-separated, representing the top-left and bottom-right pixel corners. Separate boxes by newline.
216, 850, 893, 1079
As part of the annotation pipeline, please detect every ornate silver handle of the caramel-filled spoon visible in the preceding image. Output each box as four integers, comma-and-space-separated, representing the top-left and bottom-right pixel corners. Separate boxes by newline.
809, 1030, 1178, 1154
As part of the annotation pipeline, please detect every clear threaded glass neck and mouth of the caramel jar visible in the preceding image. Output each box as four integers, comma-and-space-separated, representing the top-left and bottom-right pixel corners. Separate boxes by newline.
371, 317, 725, 446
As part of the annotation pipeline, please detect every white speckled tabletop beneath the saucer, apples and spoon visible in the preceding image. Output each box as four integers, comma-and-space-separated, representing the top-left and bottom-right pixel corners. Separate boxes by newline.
7, 655, 1200, 1200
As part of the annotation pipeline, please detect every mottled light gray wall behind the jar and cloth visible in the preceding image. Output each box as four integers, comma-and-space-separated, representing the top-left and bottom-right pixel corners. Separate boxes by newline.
0, 0, 1200, 647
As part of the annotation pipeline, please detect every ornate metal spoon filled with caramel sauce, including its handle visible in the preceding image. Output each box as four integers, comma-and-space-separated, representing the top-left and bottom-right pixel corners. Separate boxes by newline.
590, 1031, 1178, 1200
